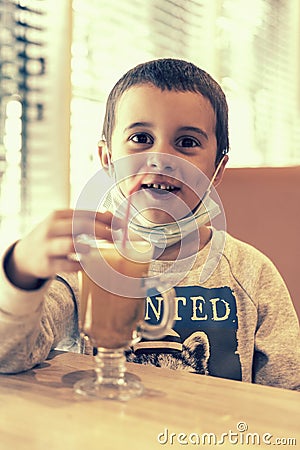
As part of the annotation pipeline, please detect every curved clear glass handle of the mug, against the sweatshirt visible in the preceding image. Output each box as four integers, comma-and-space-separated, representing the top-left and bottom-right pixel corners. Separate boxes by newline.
137, 287, 176, 339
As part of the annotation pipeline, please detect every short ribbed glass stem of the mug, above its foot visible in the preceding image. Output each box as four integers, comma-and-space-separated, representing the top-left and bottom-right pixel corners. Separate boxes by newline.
95, 347, 126, 386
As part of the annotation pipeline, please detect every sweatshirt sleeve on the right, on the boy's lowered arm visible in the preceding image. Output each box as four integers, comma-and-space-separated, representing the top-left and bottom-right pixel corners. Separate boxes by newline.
253, 259, 300, 390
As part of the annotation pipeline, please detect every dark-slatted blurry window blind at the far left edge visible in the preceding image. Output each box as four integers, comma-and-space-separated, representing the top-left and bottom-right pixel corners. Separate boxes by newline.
0, 0, 45, 243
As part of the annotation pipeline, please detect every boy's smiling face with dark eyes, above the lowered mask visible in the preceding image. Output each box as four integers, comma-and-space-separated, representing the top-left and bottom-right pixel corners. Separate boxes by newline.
99, 84, 226, 223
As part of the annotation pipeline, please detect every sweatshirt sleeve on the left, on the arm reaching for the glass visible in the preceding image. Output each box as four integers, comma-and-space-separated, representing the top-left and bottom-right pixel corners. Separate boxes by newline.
0, 244, 78, 373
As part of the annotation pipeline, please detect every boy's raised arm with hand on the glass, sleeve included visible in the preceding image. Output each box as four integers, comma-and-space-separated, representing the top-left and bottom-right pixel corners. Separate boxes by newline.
0, 210, 117, 373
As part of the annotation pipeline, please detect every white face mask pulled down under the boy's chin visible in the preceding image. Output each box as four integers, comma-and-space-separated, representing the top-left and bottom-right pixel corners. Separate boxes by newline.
104, 157, 224, 248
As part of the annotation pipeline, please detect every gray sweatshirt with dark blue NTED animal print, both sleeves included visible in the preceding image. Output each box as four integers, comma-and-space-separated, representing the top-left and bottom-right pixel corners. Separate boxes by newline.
0, 230, 300, 390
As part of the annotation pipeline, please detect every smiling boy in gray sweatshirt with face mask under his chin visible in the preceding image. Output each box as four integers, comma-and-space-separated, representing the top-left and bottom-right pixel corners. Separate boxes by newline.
0, 59, 299, 389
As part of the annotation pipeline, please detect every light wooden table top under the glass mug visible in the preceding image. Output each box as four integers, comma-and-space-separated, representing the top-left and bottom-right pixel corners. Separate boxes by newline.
0, 352, 300, 450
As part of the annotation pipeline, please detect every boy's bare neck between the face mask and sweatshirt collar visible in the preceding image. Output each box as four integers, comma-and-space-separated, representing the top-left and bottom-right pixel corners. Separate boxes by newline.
157, 226, 212, 261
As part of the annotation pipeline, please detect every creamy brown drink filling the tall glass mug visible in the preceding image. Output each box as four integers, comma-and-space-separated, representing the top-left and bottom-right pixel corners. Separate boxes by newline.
80, 241, 150, 349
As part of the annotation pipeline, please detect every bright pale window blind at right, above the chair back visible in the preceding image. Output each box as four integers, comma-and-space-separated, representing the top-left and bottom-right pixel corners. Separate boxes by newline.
218, 0, 300, 166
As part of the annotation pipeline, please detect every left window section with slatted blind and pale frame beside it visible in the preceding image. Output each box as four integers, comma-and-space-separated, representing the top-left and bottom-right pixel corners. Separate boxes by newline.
0, 0, 70, 243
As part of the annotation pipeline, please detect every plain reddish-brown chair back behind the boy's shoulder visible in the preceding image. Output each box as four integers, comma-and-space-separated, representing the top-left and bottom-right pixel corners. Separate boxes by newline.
218, 166, 300, 317
